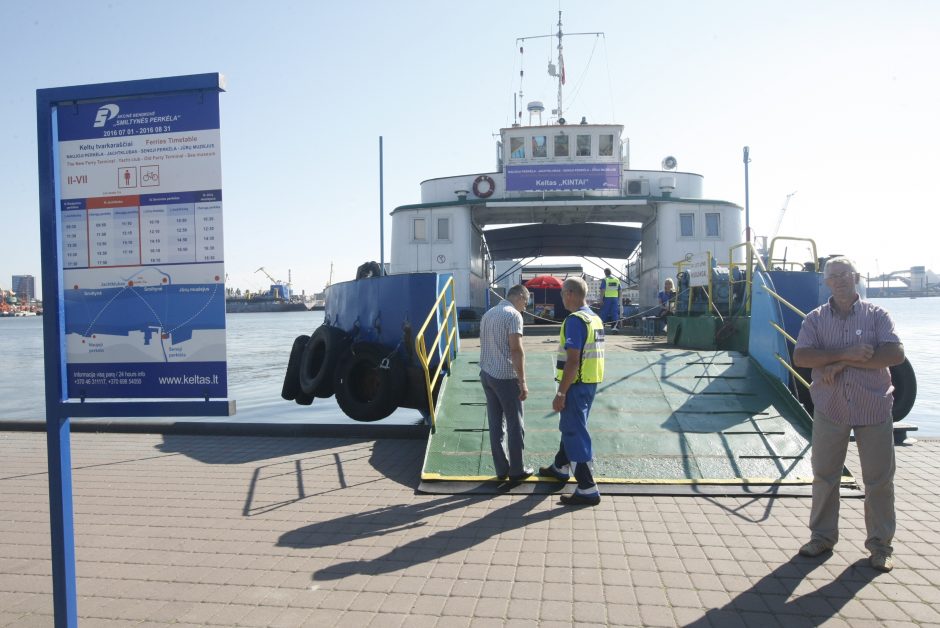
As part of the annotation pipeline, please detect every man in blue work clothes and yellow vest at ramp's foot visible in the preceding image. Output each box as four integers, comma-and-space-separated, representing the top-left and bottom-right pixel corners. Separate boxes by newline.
539, 277, 604, 506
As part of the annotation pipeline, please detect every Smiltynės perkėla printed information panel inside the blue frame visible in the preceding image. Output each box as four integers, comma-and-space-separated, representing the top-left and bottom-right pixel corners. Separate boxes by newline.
54, 91, 227, 399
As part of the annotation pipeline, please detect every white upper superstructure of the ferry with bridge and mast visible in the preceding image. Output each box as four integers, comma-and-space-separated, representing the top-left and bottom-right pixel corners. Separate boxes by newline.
389, 12, 744, 309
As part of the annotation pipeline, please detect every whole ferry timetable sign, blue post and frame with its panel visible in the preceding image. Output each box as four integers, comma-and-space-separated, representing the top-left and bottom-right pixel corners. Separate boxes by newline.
36, 74, 235, 626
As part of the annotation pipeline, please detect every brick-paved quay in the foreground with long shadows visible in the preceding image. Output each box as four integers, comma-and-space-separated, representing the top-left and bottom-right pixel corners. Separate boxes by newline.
0, 432, 940, 628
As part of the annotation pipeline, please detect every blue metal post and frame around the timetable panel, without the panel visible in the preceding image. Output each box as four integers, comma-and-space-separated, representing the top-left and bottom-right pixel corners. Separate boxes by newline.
36, 73, 235, 626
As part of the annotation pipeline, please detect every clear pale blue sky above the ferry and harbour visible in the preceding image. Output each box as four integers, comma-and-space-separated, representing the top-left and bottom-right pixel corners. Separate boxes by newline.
0, 0, 940, 300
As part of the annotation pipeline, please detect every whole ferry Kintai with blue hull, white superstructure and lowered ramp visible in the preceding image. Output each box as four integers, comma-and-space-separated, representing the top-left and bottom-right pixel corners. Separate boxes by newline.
282, 12, 916, 492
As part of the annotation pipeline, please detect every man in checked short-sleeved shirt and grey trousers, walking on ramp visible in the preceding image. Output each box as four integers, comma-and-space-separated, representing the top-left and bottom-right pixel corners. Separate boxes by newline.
480, 285, 533, 482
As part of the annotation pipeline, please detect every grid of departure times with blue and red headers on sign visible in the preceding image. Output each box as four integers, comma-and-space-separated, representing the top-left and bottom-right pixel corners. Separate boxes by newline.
62, 190, 223, 269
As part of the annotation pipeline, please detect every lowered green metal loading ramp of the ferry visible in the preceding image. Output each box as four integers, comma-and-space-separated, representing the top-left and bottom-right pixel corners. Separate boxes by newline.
419, 349, 858, 495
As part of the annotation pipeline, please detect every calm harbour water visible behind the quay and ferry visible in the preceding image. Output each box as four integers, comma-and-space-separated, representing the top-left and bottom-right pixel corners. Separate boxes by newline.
0, 298, 940, 436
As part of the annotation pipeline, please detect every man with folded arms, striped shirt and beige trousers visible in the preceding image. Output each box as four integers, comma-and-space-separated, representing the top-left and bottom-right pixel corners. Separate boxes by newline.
793, 257, 904, 571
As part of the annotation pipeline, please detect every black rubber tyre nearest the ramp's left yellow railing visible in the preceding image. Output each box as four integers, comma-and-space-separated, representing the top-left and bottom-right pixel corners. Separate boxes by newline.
333, 342, 408, 422
